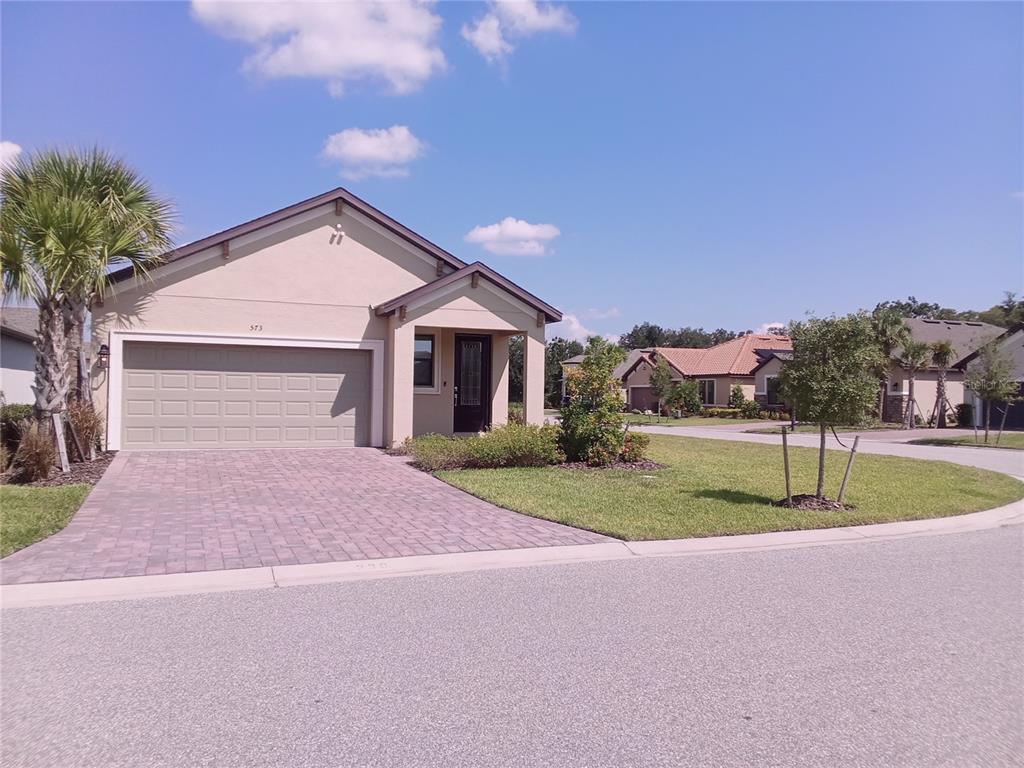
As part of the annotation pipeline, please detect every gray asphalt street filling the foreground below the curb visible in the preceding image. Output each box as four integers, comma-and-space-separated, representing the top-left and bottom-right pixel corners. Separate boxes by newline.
0, 526, 1024, 768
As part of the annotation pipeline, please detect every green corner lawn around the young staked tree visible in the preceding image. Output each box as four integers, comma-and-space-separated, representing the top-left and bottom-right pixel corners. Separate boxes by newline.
439, 435, 1024, 540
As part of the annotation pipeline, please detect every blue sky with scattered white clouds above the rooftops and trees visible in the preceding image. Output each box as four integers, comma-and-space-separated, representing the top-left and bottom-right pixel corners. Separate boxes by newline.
0, 2, 1024, 335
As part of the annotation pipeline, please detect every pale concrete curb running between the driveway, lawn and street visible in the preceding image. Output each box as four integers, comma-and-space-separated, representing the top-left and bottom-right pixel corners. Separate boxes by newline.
0, 501, 1024, 609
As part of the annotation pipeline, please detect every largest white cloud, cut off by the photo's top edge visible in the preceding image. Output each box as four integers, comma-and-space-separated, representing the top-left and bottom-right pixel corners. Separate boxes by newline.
191, 0, 446, 96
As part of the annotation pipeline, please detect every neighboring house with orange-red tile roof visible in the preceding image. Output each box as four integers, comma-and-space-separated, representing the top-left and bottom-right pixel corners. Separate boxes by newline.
622, 334, 793, 411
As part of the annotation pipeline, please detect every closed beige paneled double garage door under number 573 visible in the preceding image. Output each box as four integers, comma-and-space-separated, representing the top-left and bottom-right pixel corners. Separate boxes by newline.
121, 342, 371, 450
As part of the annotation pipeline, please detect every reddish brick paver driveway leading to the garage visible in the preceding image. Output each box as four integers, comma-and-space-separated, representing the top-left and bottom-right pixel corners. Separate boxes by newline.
0, 449, 608, 584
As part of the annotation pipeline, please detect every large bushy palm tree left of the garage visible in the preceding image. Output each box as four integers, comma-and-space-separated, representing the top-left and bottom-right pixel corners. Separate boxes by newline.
0, 150, 173, 413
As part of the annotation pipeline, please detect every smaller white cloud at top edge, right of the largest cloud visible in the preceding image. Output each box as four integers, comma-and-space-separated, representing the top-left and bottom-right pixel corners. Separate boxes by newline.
462, 0, 577, 62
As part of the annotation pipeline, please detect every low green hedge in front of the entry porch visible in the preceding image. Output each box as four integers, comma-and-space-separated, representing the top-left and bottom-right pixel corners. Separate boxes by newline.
409, 424, 565, 472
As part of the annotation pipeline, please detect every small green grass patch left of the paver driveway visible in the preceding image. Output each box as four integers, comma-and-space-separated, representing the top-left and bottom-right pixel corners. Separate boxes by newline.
0, 485, 92, 557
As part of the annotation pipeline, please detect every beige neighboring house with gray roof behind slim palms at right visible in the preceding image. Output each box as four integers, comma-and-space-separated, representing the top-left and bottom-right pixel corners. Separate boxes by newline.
882, 317, 1006, 423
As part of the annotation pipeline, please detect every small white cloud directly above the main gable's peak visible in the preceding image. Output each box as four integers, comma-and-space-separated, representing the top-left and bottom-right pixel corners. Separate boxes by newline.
321, 125, 427, 181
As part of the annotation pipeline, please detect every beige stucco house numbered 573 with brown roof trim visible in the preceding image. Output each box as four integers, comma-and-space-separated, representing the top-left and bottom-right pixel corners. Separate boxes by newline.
93, 188, 561, 450
